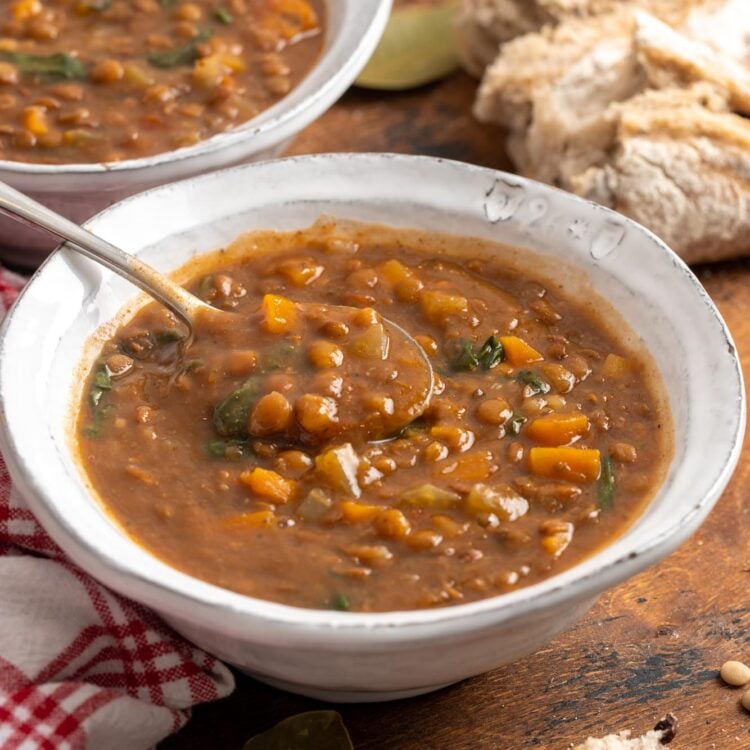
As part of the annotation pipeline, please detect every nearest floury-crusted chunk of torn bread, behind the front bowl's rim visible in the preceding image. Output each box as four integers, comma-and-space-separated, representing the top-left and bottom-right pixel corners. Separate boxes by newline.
565, 83, 750, 263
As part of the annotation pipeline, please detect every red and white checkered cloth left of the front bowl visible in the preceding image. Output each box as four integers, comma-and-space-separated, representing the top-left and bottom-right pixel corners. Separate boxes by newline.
0, 269, 234, 750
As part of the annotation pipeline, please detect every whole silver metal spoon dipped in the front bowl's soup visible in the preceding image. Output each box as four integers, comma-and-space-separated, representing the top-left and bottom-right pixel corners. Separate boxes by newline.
0, 182, 434, 439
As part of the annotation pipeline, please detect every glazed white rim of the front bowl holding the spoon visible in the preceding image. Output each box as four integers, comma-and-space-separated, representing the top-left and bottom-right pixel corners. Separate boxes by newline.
0, 153, 746, 645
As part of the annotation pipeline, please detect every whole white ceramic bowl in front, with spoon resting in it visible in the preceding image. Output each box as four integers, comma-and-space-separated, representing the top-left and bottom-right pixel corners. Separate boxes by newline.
0, 155, 745, 701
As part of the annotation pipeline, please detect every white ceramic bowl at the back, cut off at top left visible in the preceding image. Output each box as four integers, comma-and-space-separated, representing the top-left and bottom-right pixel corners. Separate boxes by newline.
0, 0, 391, 268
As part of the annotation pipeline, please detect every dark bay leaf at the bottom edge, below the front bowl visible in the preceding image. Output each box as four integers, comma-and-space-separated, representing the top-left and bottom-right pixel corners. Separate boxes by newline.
243, 711, 354, 750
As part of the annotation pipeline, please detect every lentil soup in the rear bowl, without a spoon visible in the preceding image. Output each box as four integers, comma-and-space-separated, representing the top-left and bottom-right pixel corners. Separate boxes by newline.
0, 0, 325, 164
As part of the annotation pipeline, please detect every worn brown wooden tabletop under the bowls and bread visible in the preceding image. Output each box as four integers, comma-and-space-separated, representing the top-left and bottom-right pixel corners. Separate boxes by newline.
160, 69, 750, 750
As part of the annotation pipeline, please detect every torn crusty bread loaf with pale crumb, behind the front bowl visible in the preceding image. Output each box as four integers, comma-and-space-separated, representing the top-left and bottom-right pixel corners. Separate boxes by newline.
468, 0, 750, 262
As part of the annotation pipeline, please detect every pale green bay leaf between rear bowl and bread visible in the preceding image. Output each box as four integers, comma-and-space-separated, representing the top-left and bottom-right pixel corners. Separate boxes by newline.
355, 2, 458, 91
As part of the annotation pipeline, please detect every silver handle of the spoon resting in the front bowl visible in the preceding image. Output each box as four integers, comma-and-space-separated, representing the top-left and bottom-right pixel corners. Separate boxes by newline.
0, 182, 207, 328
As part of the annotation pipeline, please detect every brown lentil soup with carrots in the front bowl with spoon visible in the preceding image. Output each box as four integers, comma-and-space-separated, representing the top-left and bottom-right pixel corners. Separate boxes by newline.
76, 221, 672, 611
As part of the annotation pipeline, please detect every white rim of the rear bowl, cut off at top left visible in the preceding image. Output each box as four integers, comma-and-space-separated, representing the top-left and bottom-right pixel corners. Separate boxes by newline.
0, 0, 392, 177
